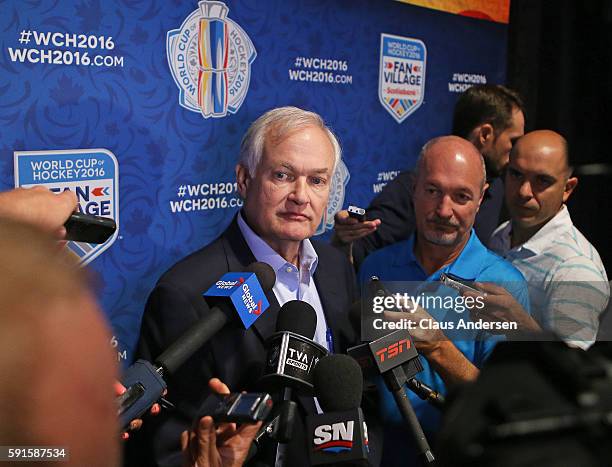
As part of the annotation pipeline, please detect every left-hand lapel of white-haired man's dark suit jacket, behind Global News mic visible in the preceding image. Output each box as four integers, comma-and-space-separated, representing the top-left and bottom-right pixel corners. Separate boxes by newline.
223, 217, 280, 341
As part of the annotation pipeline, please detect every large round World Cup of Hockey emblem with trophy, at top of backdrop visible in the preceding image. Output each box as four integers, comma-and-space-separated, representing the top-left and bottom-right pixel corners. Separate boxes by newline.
166, 1, 257, 118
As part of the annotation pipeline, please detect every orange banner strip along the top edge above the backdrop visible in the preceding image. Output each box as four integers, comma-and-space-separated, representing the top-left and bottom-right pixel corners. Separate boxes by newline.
398, 0, 510, 24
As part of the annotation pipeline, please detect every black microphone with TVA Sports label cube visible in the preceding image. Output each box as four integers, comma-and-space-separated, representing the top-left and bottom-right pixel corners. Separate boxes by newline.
260, 300, 327, 395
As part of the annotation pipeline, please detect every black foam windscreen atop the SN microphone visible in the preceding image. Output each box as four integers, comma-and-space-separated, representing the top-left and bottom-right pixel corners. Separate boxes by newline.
313, 354, 363, 412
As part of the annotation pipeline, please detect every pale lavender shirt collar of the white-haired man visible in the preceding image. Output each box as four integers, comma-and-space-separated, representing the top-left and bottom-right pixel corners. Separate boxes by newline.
238, 212, 319, 276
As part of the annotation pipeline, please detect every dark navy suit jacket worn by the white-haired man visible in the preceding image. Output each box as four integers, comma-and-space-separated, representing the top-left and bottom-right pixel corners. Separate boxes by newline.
127, 219, 372, 466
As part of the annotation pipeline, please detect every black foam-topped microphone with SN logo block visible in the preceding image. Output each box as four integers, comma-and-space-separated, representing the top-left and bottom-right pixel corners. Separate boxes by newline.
306, 355, 369, 466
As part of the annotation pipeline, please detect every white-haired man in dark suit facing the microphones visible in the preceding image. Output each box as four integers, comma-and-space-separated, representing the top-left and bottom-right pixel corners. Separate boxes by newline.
129, 107, 357, 466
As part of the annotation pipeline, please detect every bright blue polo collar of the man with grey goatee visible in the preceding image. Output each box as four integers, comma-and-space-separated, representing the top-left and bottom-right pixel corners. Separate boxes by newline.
394, 229, 486, 280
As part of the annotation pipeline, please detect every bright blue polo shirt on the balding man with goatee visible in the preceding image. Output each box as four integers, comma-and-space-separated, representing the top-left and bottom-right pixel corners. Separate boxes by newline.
359, 229, 529, 466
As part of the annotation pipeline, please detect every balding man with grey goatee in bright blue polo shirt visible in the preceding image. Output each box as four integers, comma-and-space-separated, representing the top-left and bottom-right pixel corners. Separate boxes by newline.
359, 136, 529, 466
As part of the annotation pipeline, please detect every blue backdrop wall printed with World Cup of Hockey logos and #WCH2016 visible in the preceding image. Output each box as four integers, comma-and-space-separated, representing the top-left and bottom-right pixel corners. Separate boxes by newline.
0, 0, 507, 361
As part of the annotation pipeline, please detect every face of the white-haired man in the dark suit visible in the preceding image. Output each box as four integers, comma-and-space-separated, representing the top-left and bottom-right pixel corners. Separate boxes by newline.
237, 126, 334, 251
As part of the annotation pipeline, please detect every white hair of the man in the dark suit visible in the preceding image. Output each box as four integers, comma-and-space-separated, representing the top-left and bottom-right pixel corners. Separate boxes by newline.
240, 107, 342, 177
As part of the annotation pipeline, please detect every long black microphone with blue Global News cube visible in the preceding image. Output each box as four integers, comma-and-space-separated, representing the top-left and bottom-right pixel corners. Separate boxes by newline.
117, 262, 276, 428
